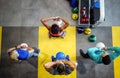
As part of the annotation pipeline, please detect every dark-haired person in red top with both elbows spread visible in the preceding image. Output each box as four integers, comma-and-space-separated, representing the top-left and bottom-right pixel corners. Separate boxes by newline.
41, 17, 69, 38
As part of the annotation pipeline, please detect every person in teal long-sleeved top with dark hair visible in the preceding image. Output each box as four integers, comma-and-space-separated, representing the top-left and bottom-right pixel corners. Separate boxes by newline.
80, 42, 120, 65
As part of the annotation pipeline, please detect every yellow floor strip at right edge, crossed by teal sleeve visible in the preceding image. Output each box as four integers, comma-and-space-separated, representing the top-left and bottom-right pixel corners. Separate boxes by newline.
112, 26, 120, 78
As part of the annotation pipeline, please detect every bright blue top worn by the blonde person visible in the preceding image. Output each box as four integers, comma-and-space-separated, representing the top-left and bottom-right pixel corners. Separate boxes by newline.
17, 49, 29, 60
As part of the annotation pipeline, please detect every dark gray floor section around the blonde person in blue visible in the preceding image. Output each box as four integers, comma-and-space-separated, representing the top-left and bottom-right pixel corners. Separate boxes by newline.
0, 27, 38, 78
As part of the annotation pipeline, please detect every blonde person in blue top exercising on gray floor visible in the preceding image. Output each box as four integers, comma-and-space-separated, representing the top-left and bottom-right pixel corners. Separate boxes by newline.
7, 43, 40, 61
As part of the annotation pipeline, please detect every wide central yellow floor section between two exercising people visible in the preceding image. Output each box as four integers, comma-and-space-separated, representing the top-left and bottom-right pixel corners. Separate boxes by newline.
38, 26, 76, 78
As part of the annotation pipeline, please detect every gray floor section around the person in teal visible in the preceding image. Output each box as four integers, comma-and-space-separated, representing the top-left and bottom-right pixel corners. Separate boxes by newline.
76, 27, 114, 78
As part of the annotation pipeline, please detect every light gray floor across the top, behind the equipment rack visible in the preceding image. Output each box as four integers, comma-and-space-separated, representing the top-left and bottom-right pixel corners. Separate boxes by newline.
0, 0, 120, 27
